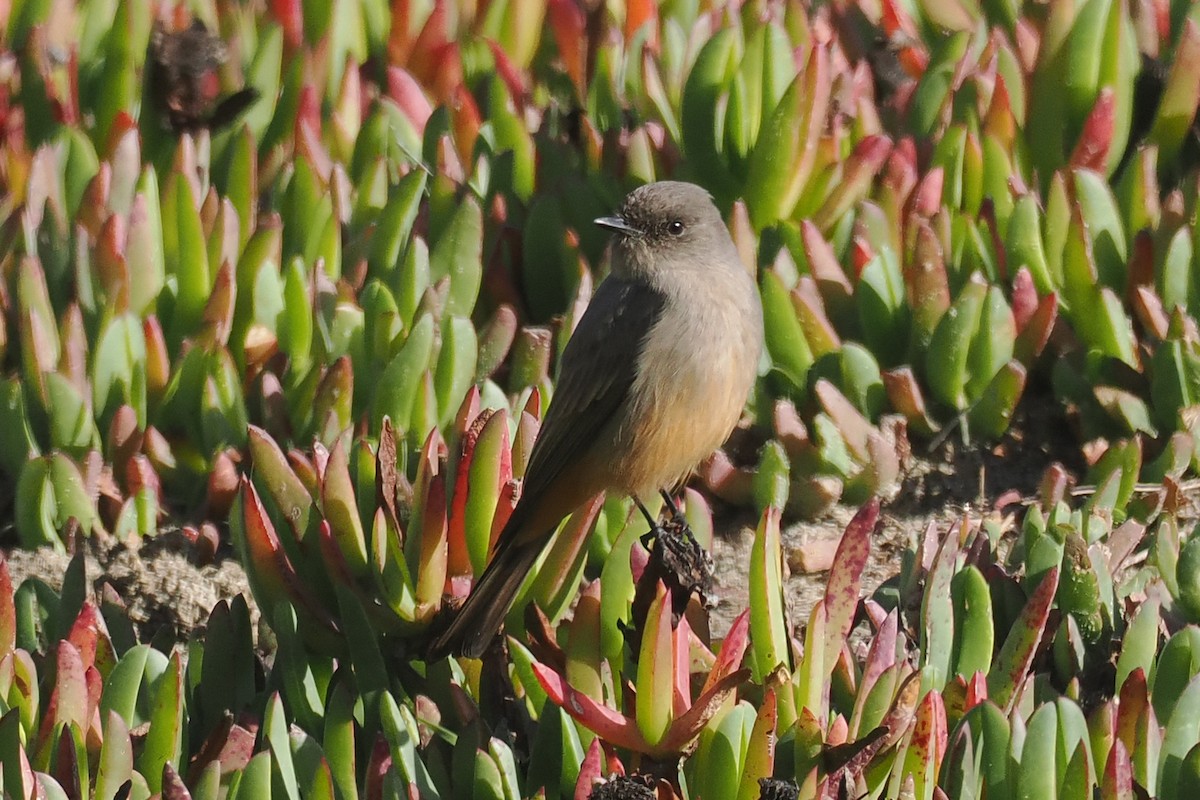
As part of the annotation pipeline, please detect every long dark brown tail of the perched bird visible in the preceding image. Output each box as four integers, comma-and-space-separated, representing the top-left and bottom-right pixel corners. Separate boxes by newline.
427, 531, 545, 661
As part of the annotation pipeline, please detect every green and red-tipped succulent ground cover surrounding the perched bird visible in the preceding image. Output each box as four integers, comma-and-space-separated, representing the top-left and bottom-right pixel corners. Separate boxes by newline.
0, 0, 1200, 800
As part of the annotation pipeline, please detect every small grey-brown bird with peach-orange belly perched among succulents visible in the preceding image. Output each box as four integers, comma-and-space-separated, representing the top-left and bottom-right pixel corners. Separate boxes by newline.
427, 181, 763, 660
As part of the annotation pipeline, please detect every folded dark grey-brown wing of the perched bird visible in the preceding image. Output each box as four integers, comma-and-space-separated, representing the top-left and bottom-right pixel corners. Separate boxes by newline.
521, 276, 666, 498
